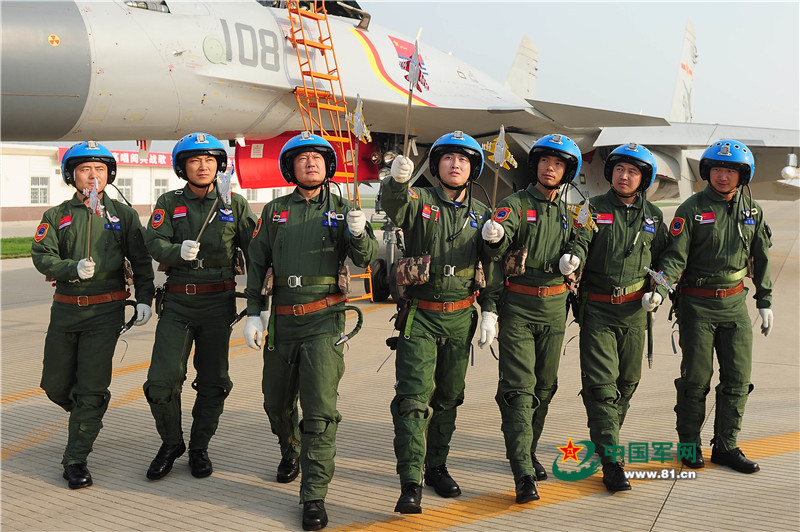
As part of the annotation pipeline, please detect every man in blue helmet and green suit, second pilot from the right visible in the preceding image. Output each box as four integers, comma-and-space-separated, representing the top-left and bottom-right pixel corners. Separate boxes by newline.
559, 143, 667, 491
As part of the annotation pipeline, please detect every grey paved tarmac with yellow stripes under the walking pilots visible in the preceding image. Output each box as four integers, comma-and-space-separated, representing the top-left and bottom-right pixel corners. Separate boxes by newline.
0, 201, 800, 532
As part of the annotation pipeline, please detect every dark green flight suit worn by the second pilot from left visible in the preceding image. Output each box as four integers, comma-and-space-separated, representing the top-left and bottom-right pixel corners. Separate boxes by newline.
144, 185, 255, 450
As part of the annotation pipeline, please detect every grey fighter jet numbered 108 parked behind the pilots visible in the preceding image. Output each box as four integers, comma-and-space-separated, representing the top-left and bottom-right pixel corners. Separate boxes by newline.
0, 0, 800, 200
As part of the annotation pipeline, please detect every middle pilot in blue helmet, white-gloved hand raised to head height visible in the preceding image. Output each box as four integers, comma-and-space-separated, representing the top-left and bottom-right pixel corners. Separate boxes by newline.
381, 131, 497, 514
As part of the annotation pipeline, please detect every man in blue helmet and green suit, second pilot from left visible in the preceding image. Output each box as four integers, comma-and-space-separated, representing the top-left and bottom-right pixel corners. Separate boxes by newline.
144, 133, 255, 480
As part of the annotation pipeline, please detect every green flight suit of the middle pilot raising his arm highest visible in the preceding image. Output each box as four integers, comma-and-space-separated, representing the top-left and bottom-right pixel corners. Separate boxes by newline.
381, 179, 499, 485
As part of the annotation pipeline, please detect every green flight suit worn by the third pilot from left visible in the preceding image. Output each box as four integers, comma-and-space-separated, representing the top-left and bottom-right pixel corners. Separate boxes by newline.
245, 189, 378, 502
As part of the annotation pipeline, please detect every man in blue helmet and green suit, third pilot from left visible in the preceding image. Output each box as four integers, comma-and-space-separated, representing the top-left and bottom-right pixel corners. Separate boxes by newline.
244, 131, 378, 530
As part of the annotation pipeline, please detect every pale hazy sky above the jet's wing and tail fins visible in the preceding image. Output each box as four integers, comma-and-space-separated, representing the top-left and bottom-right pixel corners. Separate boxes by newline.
359, 0, 800, 130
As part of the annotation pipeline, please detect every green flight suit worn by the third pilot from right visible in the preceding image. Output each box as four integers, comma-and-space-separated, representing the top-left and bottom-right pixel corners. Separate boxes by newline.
494, 184, 572, 482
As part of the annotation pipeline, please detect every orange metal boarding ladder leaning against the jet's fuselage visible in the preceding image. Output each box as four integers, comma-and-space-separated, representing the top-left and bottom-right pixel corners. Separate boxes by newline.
286, 0, 372, 301
